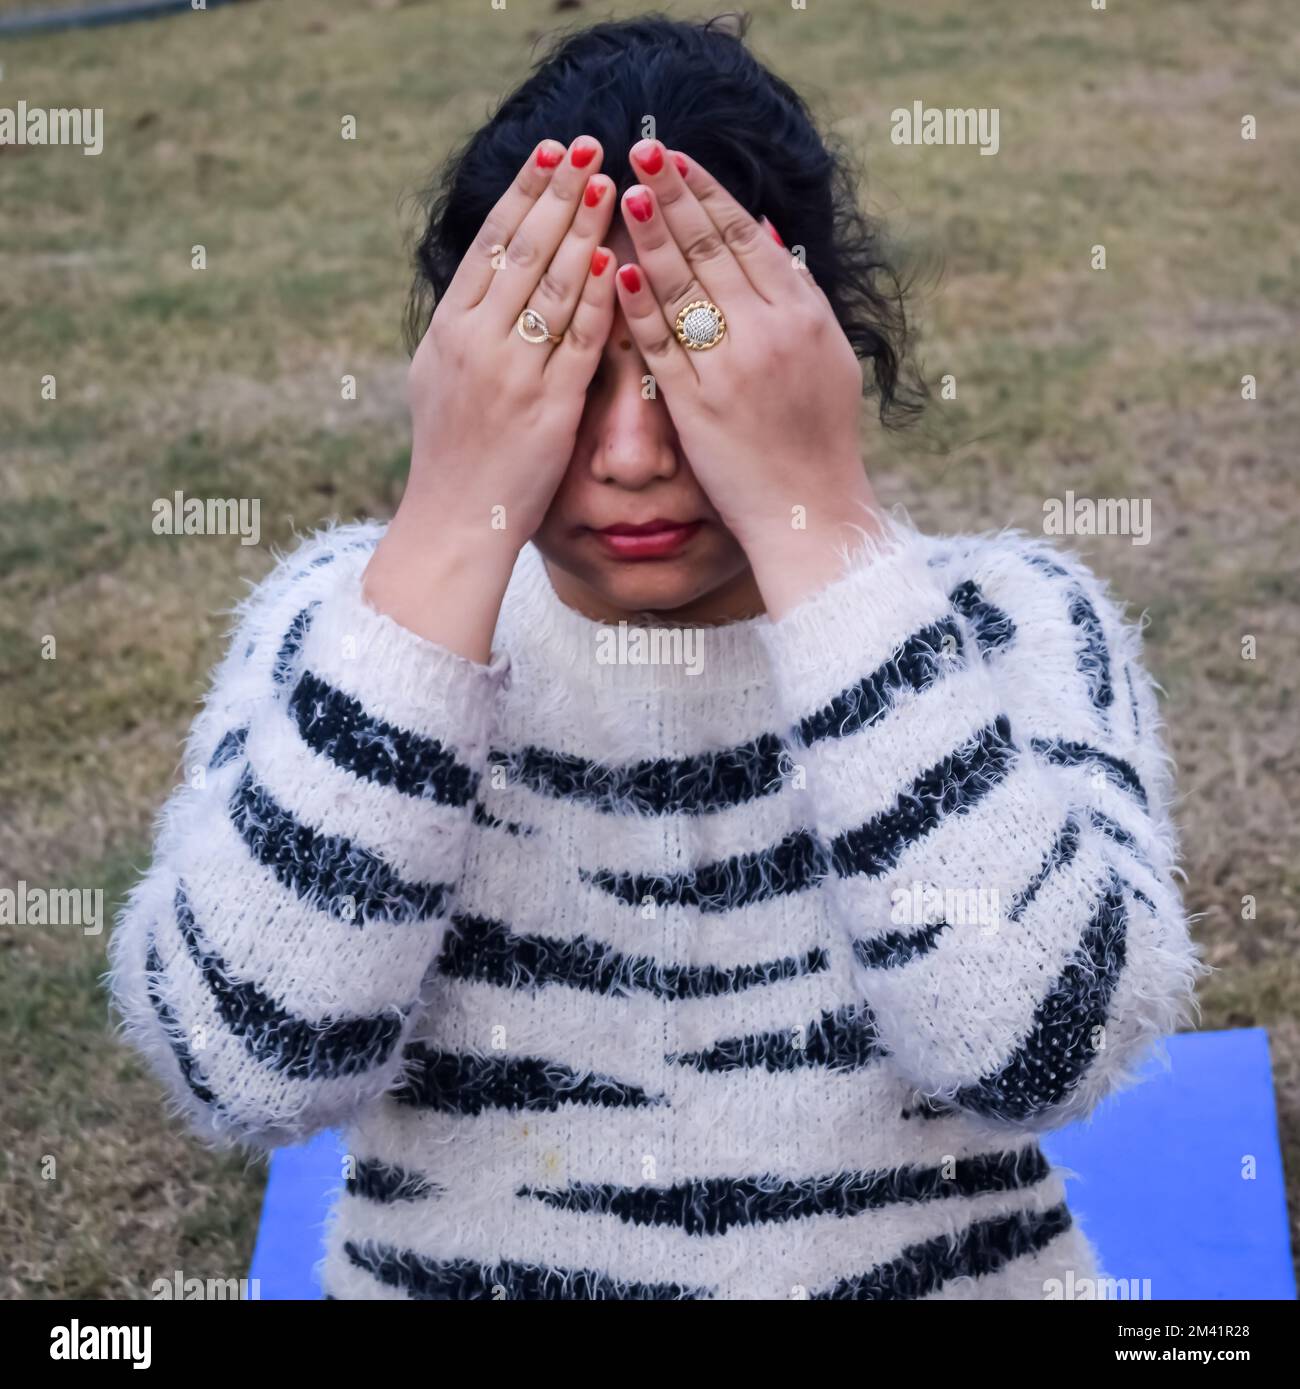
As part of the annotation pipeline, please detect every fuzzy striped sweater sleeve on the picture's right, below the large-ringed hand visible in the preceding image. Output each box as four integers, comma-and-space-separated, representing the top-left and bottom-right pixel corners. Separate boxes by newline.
764, 522, 1204, 1129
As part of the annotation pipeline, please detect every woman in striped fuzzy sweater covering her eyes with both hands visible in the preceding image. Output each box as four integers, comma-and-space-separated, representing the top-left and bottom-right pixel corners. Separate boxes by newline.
114, 19, 1197, 1299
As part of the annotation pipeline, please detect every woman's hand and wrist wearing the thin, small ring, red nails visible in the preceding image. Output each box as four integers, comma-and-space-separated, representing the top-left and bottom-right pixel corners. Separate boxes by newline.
365, 136, 614, 660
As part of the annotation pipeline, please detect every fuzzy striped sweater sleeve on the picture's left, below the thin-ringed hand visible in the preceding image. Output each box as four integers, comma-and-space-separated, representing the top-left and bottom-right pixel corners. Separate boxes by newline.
110, 526, 507, 1146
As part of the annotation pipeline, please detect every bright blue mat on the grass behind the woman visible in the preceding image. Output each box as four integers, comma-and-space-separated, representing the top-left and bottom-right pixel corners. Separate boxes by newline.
249, 1028, 1296, 1300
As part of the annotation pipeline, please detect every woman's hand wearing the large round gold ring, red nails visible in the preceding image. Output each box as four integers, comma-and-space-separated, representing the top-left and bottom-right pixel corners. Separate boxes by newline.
618, 140, 876, 617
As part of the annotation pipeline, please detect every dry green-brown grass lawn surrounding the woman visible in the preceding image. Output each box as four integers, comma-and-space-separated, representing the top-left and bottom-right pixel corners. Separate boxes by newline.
0, 0, 1300, 1297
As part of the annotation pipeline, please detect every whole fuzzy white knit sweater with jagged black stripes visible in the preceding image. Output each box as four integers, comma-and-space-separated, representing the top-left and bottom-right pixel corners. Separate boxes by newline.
111, 522, 1203, 1300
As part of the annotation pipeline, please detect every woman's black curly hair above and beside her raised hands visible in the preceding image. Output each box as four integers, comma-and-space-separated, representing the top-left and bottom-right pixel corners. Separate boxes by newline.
407, 14, 926, 426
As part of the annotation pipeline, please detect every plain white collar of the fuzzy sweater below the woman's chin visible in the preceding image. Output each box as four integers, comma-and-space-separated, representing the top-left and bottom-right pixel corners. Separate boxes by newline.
493, 543, 771, 696
